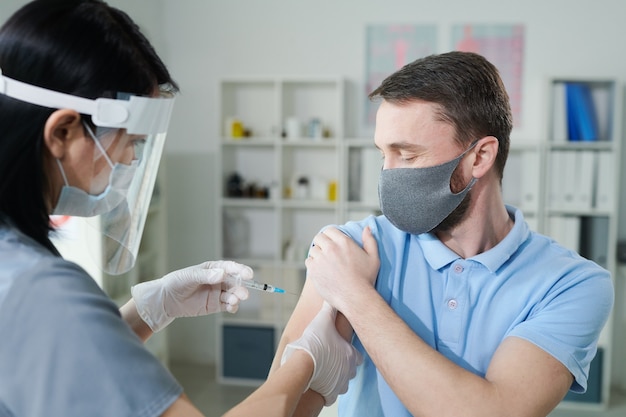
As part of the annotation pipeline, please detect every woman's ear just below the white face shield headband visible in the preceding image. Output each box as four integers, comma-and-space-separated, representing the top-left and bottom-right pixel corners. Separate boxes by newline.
43, 109, 85, 159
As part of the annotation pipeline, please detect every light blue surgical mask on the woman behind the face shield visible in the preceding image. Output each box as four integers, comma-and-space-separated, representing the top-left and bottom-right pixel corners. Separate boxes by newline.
52, 126, 138, 217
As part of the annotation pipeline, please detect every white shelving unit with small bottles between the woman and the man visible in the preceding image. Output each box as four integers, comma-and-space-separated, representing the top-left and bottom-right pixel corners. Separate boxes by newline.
215, 77, 381, 385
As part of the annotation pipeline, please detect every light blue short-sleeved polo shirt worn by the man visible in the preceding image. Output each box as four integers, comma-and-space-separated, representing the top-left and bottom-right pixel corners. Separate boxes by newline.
339, 207, 614, 417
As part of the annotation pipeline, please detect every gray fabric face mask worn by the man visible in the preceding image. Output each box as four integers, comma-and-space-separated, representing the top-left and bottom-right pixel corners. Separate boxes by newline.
378, 143, 477, 235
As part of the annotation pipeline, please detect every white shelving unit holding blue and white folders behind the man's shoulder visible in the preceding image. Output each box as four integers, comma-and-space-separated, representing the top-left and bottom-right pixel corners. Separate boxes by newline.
503, 78, 622, 411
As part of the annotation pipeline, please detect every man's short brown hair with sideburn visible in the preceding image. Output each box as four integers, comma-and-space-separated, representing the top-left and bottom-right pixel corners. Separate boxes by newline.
369, 51, 513, 179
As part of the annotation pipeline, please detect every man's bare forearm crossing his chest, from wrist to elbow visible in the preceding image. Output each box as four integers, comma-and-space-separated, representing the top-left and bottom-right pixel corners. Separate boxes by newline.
336, 290, 498, 416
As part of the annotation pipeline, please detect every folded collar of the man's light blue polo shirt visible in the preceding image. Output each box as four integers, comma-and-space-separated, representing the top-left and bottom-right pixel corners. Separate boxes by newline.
416, 206, 530, 272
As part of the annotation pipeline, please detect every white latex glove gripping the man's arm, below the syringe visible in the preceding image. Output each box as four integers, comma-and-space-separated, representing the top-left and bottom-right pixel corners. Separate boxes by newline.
280, 301, 363, 406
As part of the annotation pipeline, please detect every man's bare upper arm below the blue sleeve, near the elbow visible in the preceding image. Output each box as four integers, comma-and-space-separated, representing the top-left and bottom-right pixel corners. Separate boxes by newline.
485, 337, 574, 416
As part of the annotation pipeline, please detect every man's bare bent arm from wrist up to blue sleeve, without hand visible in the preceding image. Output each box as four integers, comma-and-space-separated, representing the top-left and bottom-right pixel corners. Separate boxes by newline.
344, 290, 572, 417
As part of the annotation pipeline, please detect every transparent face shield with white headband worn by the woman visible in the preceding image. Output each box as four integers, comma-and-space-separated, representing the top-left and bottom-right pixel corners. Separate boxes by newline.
0, 72, 174, 275
